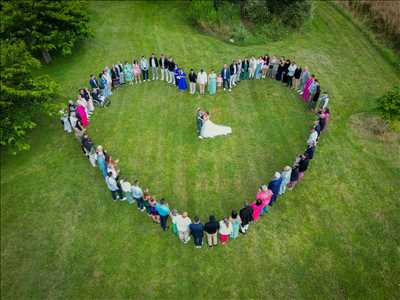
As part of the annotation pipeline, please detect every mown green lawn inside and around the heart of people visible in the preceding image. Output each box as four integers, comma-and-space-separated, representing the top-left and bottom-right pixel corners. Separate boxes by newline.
1, 1, 400, 299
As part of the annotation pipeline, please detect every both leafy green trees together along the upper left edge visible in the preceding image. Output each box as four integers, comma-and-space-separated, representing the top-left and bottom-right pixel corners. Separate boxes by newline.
0, 0, 91, 153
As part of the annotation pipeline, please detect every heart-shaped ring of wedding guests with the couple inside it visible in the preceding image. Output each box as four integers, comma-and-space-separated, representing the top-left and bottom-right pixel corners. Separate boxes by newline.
61, 54, 330, 248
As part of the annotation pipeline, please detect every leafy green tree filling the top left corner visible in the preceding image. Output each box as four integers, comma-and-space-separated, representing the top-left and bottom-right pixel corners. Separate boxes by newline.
0, 0, 91, 63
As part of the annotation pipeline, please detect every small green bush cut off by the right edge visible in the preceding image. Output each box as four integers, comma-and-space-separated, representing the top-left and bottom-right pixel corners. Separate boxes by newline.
378, 85, 400, 121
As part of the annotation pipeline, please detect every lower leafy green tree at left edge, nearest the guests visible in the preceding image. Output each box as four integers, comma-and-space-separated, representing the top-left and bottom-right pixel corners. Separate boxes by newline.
0, 42, 57, 153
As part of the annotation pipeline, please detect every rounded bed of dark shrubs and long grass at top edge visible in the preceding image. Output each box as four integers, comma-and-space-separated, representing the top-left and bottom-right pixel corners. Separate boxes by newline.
188, 0, 312, 44
